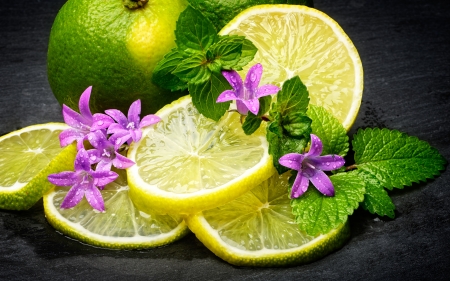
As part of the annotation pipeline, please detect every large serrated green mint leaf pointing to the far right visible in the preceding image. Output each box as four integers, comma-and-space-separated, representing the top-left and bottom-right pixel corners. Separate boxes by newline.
353, 128, 447, 189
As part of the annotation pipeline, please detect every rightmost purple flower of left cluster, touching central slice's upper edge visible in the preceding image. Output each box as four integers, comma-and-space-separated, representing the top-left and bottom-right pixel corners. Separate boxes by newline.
103, 100, 161, 145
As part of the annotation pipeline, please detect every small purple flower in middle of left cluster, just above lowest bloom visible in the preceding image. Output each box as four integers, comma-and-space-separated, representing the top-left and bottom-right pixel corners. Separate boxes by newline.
87, 130, 134, 171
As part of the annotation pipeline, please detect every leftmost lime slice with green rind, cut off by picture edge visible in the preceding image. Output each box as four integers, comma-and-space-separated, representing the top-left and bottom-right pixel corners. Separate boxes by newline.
0, 123, 76, 210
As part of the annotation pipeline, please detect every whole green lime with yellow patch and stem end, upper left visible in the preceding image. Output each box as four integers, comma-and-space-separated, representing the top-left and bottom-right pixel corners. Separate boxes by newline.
47, 0, 188, 114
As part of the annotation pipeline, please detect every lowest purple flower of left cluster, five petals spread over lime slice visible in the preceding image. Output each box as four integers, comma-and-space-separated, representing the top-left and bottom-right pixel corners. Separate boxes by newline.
48, 148, 119, 212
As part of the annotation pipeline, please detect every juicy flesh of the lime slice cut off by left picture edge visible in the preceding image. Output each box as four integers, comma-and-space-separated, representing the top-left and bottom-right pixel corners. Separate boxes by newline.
0, 129, 62, 188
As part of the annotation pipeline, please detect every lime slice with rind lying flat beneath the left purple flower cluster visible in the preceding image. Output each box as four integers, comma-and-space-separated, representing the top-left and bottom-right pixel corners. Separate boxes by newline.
44, 167, 189, 249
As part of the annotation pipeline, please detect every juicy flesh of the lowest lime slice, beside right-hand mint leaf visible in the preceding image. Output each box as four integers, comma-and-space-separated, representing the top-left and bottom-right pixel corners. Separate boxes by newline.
203, 172, 314, 251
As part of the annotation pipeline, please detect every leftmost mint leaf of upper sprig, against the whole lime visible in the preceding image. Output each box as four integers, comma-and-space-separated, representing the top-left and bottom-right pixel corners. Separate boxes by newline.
152, 48, 187, 91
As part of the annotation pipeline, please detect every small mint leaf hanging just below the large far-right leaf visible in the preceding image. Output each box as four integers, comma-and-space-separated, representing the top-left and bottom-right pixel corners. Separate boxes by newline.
357, 171, 395, 219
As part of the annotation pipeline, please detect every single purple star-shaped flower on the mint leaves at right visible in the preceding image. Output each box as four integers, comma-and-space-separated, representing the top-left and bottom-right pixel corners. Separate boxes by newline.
279, 134, 345, 198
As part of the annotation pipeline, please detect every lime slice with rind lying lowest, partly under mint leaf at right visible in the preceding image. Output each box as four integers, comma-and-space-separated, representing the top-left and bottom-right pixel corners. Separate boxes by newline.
186, 173, 350, 266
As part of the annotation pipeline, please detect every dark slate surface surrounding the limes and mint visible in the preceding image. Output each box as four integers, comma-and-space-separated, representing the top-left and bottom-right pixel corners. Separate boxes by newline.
0, 0, 450, 280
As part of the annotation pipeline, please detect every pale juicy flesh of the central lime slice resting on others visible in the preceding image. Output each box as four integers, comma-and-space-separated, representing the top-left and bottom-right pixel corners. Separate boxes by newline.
136, 100, 267, 194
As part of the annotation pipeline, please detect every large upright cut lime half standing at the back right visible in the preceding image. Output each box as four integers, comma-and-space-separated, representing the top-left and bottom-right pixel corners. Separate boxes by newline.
219, 5, 363, 130
